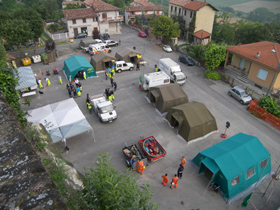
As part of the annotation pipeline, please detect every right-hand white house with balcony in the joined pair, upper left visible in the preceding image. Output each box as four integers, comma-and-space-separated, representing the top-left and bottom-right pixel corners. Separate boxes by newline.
84, 0, 123, 34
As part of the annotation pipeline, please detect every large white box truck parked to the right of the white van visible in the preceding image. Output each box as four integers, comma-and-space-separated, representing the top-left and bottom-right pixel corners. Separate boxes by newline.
158, 58, 186, 85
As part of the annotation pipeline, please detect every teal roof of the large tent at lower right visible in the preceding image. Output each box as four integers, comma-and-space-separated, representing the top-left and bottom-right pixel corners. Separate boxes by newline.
200, 133, 270, 179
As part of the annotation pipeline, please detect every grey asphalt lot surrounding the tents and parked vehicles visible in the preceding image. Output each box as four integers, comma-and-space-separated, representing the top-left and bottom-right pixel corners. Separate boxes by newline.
23, 27, 280, 210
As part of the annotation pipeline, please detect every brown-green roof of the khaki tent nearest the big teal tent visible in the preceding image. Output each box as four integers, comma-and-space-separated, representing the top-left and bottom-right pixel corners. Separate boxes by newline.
172, 101, 214, 127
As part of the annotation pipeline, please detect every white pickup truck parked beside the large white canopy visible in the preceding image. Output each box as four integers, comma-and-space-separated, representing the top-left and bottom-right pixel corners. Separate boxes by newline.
90, 94, 118, 122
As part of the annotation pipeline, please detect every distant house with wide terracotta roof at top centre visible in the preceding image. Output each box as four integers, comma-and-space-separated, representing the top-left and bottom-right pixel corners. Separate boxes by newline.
124, 0, 163, 24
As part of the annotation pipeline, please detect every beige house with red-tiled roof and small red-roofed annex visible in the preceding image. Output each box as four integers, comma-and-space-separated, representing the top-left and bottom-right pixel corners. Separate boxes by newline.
168, 0, 218, 45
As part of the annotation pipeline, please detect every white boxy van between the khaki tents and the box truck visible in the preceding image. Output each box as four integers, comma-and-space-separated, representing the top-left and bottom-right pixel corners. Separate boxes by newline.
143, 71, 170, 90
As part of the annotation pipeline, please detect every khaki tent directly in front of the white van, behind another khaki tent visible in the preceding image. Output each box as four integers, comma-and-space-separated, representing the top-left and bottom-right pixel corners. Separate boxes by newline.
147, 84, 189, 113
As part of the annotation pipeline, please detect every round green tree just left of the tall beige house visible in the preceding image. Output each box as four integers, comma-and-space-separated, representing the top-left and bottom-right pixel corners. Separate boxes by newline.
149, 15, 181, 40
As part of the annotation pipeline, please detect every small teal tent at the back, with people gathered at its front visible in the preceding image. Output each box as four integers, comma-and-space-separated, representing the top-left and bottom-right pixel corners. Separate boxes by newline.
64, 55, 97, 81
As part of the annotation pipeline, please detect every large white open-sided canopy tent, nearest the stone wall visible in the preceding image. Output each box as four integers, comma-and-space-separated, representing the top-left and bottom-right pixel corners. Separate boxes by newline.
27, 98, 94, 143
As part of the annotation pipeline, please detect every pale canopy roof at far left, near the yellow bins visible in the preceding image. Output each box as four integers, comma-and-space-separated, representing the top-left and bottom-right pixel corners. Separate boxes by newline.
15, 66, 37, 90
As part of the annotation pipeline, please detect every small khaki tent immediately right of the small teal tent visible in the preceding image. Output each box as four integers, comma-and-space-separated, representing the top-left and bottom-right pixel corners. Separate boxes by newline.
90, 52, 116, 71
